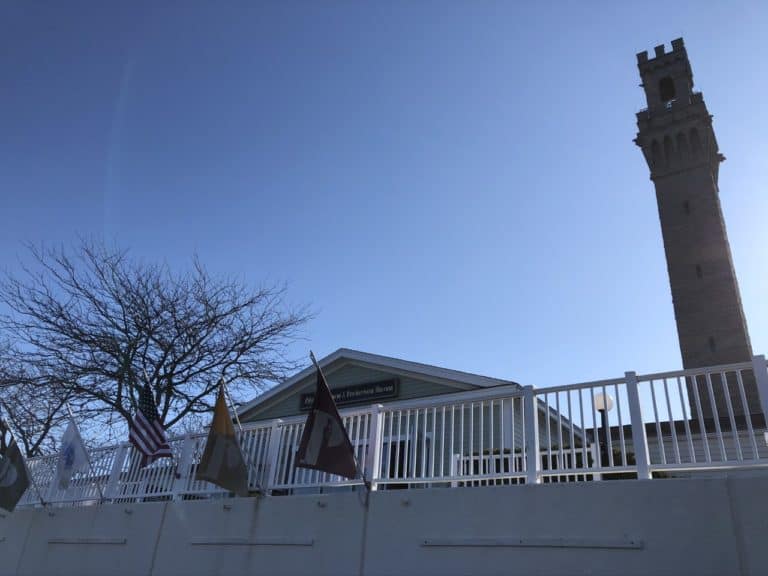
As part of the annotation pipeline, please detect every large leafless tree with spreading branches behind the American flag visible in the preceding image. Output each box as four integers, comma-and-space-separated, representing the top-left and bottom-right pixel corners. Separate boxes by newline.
0, 240, 310, 446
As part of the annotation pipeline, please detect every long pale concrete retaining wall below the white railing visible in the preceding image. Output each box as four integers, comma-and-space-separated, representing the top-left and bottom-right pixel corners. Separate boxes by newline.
0, 474, 768, 576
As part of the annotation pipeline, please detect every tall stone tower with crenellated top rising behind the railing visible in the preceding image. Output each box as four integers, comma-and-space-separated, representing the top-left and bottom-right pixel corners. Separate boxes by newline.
635, 38, 760, 418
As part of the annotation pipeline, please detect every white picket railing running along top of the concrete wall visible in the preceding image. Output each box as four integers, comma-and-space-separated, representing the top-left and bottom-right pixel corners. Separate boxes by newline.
21, 356, 768, 505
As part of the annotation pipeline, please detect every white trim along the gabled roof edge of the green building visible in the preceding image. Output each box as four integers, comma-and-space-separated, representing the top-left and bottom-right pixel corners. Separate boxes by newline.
237, 348, 519, 417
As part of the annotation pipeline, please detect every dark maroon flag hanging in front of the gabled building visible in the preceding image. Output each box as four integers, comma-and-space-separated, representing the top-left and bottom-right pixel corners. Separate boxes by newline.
296, 358, 359, 479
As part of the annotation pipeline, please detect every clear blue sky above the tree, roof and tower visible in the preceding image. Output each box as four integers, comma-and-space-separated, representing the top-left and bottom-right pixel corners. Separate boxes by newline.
0, 0, 768, 386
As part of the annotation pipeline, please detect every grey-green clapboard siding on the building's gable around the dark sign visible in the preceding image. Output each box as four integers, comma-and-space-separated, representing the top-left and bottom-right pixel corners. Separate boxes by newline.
244, 365, 468, 422
